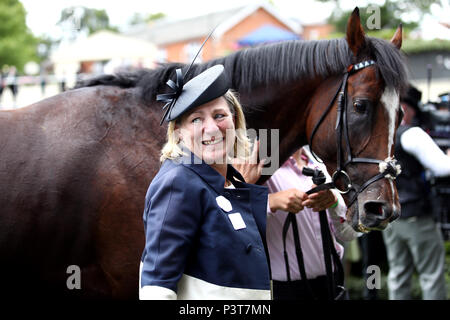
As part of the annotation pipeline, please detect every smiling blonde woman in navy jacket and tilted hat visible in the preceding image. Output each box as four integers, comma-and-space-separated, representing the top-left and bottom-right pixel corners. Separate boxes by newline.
139, 65, 270, 299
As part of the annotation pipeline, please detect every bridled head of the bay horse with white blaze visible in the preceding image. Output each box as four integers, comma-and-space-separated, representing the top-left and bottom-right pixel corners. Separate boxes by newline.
306, 8, 406, 232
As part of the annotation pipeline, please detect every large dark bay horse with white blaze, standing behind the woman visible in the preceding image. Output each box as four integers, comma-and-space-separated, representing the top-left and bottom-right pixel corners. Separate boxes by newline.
0, 10, 406, 299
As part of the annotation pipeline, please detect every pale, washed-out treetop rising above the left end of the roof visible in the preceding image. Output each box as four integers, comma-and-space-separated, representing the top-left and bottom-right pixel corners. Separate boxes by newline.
58, 7, 118, 35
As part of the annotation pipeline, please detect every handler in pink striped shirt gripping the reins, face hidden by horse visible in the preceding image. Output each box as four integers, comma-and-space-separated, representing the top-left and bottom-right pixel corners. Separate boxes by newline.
237, 147, 358, 300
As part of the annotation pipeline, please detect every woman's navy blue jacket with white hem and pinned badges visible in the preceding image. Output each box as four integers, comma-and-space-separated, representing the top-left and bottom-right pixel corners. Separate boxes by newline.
140, 154, 270, 299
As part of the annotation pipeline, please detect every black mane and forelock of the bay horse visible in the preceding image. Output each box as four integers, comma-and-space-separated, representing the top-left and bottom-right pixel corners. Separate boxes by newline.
75, 37, 408, 103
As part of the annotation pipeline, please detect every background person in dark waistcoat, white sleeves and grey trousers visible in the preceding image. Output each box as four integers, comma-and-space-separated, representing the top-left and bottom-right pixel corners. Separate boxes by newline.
383, 86, 450, 300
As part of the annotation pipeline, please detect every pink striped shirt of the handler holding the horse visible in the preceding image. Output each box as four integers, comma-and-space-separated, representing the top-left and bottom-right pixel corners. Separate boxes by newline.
265, 157, 347, 281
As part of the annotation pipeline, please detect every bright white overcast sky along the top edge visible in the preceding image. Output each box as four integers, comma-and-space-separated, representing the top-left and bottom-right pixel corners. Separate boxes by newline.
20, 0, 450, 39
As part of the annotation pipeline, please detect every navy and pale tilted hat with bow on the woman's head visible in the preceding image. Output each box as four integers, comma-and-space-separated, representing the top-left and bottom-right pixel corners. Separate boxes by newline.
156, 64, 230, 123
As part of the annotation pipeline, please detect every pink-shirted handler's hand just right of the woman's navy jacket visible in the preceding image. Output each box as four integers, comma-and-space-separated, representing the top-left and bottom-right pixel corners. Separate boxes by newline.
269, 188, 308, 213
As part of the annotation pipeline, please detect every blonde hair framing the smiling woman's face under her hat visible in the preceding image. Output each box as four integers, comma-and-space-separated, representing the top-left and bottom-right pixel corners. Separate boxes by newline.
159, 90, 250, 162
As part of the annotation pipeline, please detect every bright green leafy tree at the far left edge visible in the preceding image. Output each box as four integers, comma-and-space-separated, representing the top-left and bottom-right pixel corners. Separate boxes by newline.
0, 0, 37, 71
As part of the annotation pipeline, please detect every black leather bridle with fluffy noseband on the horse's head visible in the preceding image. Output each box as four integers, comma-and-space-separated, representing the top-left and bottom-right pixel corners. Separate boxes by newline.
309, 60, 401, 229
